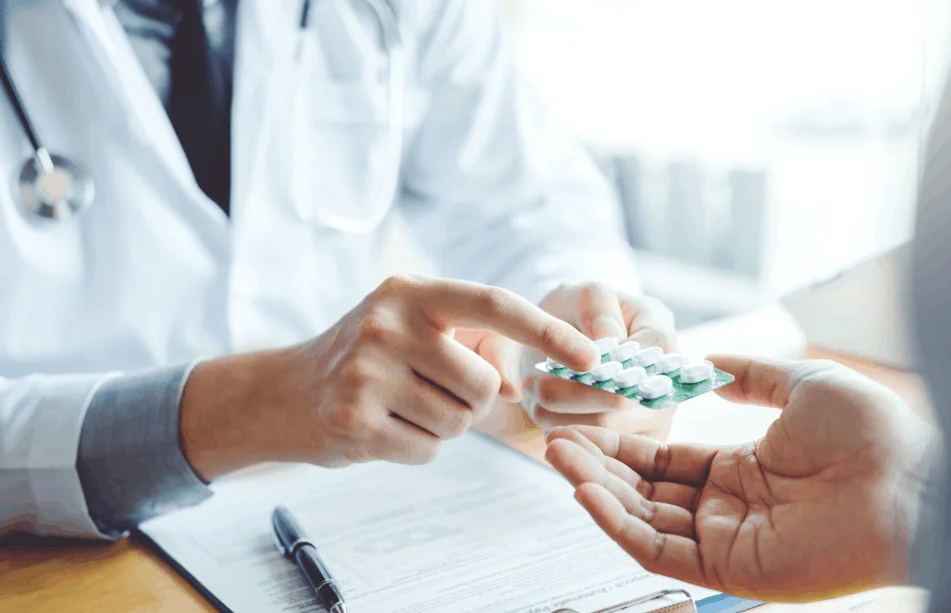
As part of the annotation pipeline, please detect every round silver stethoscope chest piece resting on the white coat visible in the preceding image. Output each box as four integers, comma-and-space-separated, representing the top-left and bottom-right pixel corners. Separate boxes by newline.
19, 150, 95, 221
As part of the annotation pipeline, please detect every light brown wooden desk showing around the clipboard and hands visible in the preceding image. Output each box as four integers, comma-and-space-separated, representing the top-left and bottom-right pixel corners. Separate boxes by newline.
0, 351, 927, 613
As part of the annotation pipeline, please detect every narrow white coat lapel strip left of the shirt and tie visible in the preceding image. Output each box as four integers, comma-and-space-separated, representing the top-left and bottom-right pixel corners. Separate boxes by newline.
63, 0, 227, 223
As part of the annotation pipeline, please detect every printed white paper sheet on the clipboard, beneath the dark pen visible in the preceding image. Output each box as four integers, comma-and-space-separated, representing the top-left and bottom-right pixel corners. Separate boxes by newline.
140, 434, 714, 613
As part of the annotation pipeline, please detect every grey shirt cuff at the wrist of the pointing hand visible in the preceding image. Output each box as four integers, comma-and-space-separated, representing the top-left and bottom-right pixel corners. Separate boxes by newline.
76, 362, 211, 536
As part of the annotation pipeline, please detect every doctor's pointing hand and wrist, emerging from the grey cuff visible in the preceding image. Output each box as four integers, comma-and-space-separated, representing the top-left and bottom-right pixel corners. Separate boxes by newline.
180, 278, 599, 479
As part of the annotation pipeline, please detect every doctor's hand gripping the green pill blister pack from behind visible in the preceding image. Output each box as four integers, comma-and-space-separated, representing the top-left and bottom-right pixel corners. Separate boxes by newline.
522, 283, 676, 439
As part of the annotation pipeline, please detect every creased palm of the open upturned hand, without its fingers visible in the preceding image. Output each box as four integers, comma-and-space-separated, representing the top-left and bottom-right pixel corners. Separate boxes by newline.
694, 410, 907, 599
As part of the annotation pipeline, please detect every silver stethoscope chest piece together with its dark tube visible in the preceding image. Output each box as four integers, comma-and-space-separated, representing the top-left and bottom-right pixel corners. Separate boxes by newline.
0, 51, 96, 221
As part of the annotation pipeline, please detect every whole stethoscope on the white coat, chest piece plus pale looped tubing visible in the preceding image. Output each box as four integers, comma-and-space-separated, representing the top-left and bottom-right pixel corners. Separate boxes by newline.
0, 0, 405, 232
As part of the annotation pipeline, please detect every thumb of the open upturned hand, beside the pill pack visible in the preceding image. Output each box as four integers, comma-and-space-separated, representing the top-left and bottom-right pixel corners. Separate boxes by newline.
708, 356, 804, 409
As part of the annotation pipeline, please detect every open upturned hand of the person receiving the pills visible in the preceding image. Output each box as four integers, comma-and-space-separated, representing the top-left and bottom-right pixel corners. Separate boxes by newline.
547, 358, 931, 601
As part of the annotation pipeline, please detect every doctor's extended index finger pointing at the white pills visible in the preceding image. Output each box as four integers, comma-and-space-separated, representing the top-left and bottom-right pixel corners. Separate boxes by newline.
417, 279, 600, 370
